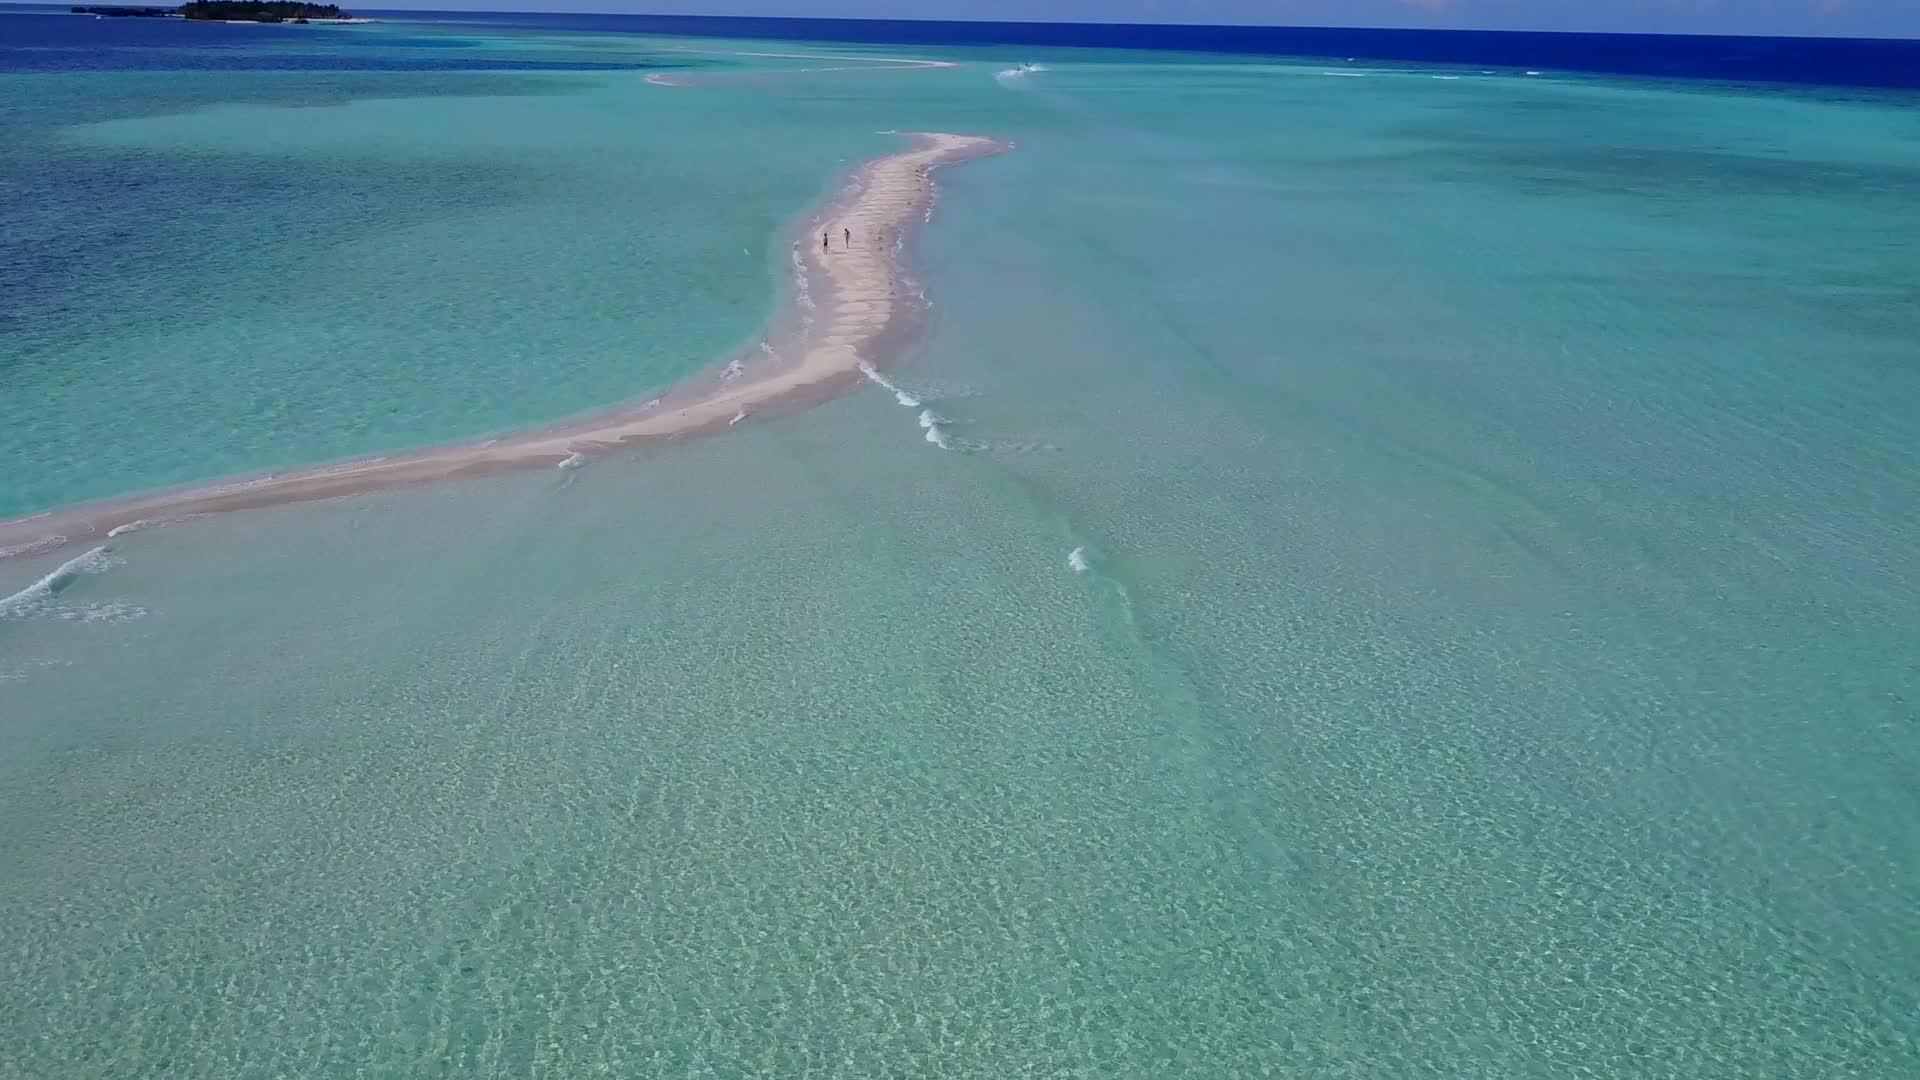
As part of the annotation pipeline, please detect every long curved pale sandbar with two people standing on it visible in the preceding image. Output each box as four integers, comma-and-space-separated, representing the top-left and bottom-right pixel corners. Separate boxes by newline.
0, 133, 1010, 561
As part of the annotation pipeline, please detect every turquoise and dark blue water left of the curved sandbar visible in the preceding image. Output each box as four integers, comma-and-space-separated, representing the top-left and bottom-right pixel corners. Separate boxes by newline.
0, 17, 902, 515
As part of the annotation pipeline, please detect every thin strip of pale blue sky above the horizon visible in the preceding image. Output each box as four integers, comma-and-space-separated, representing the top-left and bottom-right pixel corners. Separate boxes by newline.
389, 0, 1920, 37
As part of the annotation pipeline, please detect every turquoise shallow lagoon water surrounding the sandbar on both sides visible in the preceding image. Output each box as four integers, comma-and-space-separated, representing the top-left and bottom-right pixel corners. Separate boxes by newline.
0, 14, 1920, 1078
